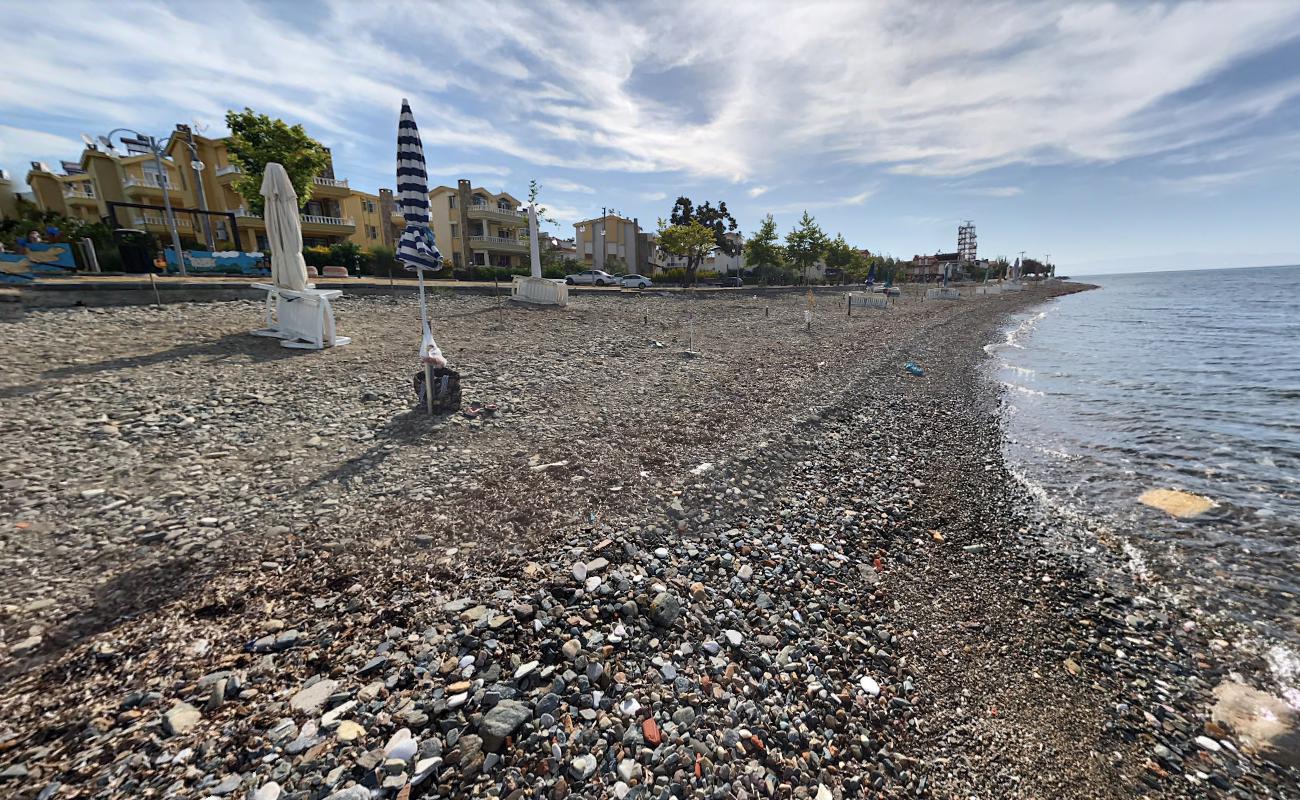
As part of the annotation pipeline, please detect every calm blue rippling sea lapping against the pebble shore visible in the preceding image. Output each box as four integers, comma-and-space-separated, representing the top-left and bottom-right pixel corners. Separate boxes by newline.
987, 267, 1300, 708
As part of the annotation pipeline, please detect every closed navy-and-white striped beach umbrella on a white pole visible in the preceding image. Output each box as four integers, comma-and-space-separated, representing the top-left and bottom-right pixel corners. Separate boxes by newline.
398, 98, 446, 366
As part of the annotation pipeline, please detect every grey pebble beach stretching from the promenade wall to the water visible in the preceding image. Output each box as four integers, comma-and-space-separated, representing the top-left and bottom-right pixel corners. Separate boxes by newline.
0, 284, 1300, 800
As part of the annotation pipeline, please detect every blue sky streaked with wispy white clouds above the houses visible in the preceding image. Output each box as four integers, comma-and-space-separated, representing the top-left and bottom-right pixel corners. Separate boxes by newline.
0, 0, 1300, 274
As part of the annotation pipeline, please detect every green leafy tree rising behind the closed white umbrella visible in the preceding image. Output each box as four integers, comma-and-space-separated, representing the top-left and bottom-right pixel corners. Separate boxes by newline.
226, 108, 329, 213
